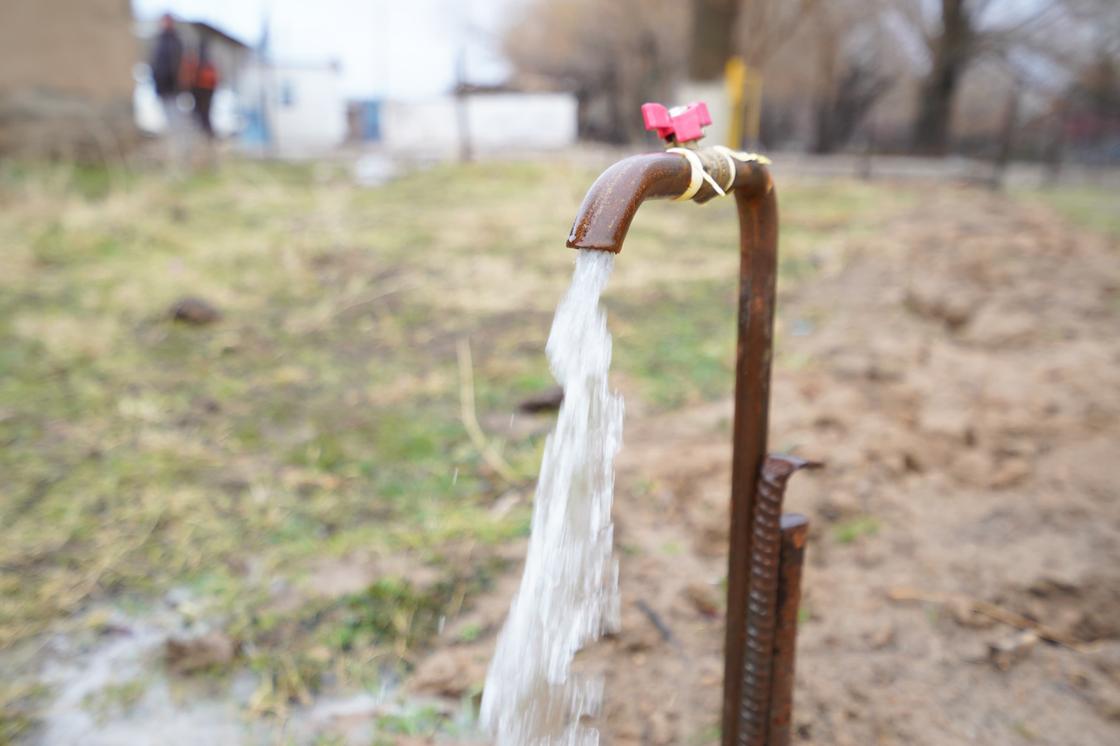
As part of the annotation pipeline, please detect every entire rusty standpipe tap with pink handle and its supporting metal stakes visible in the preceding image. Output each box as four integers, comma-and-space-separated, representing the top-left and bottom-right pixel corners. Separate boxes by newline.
568, 103, 816, 746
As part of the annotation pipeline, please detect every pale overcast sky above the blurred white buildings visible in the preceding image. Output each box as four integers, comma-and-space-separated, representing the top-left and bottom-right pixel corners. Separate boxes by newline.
132, 0, 525, 99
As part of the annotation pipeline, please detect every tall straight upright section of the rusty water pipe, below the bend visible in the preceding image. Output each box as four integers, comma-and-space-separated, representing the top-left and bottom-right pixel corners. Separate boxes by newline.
722, 175, 777, 746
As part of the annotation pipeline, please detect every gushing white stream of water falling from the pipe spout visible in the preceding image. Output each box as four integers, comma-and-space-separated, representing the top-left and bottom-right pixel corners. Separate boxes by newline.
480, 246, 623, 746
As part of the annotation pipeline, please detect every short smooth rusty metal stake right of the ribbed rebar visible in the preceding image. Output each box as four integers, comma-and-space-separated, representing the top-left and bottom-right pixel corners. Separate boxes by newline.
766, 513, 809, 746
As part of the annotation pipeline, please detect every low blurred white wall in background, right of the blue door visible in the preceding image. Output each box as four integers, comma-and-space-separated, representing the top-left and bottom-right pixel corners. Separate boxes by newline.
381, 93, 577, 159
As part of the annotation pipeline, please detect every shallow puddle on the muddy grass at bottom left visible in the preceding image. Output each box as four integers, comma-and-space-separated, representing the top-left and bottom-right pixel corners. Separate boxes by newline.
14, 608, 463, 746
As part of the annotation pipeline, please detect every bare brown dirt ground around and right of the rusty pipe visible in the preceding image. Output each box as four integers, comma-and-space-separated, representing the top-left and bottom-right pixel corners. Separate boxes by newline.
410, 182, 1120, 746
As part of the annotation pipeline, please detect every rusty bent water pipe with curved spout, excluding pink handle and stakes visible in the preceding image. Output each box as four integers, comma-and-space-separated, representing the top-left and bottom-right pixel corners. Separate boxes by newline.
568, 149, 777, 746
